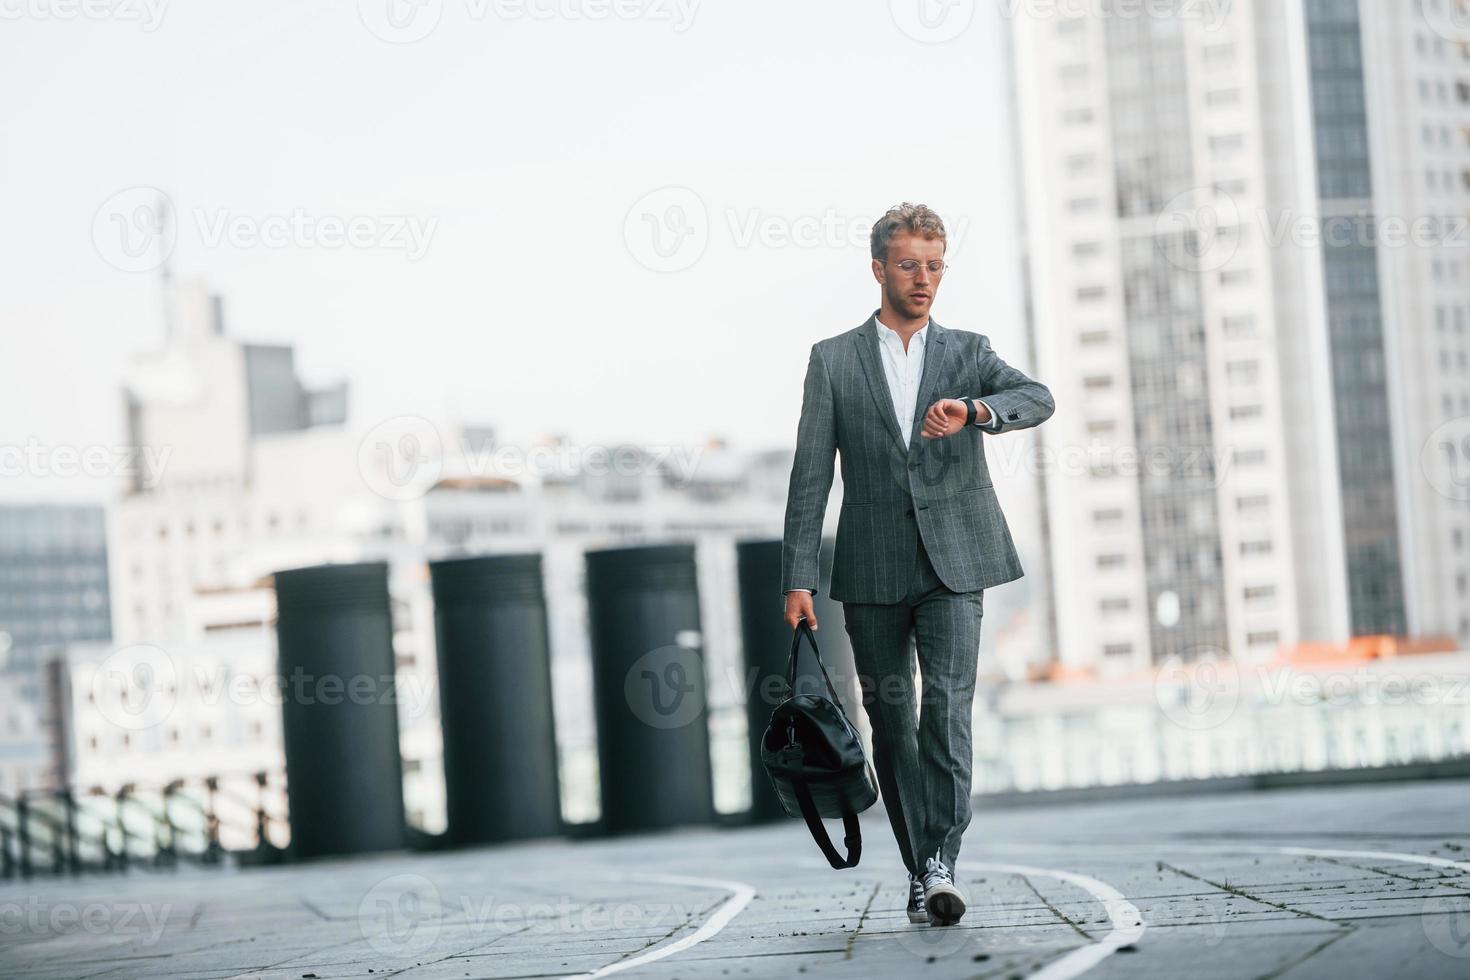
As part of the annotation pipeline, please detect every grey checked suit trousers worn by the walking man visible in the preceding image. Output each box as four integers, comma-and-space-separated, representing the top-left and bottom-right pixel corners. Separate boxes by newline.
842, 539, 985, 874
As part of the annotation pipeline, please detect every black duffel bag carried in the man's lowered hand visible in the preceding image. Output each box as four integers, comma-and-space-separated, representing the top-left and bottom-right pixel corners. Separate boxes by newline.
760, 620, 878, 868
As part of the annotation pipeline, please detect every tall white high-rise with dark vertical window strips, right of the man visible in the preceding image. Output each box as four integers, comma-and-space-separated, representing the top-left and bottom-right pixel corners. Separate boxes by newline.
1010, 0, 1470, 673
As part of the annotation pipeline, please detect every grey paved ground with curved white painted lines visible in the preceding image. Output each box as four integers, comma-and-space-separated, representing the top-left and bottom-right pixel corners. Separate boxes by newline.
0, 780, 1470, 980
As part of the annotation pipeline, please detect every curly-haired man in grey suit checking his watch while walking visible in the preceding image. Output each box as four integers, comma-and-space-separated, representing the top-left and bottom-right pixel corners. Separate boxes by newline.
781, 204, 1054, 926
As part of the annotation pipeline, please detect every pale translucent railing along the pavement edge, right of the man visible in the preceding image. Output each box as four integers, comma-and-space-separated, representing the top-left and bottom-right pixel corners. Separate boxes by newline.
975, 654, 1470, 793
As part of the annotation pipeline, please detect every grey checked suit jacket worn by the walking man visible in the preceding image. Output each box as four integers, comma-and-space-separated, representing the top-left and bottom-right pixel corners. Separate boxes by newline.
781, 310, 1055, 602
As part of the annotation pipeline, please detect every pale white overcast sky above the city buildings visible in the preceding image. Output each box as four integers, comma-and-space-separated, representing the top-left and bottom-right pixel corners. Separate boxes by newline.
0, 0, 1025, 500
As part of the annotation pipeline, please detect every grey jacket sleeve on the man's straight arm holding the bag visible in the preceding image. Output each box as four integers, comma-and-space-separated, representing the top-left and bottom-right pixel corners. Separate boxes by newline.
781, 344, 836, 595
